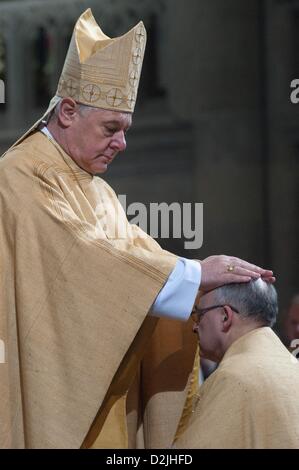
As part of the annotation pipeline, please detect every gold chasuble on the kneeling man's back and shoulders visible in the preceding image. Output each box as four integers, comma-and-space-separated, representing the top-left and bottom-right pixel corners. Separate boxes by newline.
176, 327, 299, 449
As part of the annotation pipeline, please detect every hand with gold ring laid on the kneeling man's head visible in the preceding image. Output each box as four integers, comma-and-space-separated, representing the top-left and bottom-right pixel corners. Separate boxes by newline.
196, 255, 275, 291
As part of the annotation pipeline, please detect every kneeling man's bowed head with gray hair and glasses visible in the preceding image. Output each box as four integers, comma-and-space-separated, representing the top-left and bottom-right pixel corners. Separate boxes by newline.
193, 279, 278, 362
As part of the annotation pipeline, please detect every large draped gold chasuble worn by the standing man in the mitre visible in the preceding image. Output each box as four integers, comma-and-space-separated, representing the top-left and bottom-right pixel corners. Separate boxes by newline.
0, 132, 194, 448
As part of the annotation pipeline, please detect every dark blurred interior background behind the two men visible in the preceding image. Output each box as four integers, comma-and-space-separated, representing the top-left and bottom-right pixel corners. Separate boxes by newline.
0, 0, 299, 334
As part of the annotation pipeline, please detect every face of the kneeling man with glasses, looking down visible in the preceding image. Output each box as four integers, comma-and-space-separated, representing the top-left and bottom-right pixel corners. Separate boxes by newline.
193, 291, 223, 362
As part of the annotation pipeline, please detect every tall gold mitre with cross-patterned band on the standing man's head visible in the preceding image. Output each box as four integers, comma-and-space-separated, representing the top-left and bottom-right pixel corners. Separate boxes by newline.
56, 8, 146, 113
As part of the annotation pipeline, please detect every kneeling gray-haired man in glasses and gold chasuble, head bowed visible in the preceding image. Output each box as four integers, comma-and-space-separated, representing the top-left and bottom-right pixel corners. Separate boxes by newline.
175, 279, 299, 449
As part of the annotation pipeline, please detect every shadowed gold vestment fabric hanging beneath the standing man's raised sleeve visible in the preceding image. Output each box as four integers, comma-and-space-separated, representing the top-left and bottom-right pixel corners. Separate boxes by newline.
83, 317, 199, 449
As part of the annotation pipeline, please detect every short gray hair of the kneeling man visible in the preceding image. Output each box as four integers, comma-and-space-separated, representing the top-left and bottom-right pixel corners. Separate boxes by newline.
214, 278, 278, 327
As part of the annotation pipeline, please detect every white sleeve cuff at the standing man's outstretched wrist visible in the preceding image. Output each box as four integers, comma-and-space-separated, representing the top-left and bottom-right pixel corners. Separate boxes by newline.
149, 258, 201, 321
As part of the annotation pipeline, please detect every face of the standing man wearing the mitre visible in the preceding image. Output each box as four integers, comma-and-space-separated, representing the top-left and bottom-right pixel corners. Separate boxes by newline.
65, 109, 132, 175
